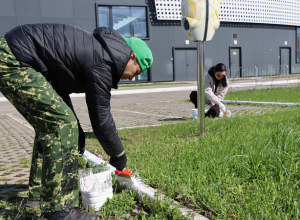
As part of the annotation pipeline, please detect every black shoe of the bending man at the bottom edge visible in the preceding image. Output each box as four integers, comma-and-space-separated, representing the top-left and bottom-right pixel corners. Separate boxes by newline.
41, 208, 98, 220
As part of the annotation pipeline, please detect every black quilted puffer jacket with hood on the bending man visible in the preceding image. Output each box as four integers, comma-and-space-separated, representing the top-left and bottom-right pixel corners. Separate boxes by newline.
5, 24, 132, 155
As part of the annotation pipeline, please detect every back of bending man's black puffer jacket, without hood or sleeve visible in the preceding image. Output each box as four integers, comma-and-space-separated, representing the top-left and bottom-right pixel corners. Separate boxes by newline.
5, 24, 101, 92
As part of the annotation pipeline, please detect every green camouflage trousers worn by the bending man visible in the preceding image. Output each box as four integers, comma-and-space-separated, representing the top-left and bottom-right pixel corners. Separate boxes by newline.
0, 38, 79, 212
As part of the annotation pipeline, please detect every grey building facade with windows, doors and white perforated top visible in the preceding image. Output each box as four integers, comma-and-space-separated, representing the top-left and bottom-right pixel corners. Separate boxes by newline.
0, 0, 300, 82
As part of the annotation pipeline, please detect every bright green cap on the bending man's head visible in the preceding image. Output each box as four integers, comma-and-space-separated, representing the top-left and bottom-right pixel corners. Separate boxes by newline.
122, 36, 153, 73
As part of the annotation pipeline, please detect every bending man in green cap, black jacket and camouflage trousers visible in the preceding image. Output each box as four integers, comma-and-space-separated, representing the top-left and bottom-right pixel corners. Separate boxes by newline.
0, 23, 153, 220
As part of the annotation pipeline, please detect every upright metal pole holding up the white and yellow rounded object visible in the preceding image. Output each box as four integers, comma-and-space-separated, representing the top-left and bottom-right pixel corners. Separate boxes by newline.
197, 41, 205, 136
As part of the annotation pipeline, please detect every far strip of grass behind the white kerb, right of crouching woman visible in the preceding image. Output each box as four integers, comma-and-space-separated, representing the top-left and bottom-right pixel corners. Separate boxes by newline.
225, 87, 300, 103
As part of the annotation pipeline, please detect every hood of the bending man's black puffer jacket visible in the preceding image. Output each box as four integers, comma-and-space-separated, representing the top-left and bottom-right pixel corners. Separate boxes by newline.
93, 27, 132, 89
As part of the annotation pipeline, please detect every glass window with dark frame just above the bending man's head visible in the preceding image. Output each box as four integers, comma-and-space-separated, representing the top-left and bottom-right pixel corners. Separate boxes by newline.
98, 6, 148, 38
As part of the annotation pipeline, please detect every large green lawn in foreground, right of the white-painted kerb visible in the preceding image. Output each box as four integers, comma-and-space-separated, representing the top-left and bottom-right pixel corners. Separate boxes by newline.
88, 88, 300, 219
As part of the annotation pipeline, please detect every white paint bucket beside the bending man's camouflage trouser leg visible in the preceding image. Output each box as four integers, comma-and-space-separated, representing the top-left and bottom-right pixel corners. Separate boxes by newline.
79, 167, 113, 211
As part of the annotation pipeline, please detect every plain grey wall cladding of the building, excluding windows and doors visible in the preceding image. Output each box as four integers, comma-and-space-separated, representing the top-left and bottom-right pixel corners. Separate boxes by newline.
0, 0, 300, 81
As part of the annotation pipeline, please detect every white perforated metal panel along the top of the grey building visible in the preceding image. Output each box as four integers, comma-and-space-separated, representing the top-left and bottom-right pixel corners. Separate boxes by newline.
154, 0, 300, 26
